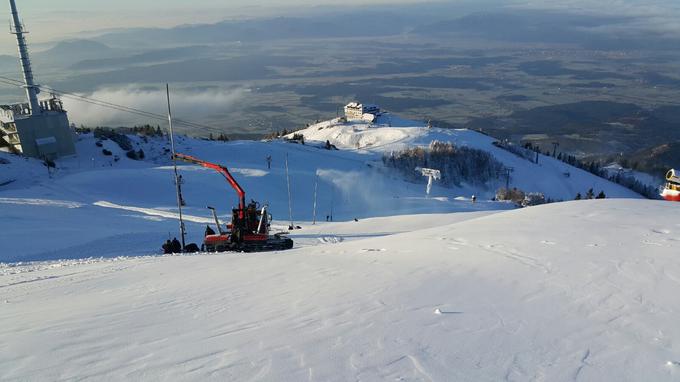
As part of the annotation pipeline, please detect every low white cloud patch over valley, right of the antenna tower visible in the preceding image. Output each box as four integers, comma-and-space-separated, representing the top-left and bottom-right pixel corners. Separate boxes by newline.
63, 86, 247, 126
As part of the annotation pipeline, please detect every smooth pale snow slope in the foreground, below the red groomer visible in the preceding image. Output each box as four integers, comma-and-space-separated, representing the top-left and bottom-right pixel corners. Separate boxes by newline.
0, 200, 680, 381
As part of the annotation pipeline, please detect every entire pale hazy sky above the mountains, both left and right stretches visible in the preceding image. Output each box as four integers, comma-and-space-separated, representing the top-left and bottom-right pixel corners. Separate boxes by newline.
0, 0, 680, 52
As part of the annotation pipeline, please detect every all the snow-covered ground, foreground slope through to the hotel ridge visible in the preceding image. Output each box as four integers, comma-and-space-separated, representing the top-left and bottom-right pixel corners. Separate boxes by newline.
0, 117, 680, 381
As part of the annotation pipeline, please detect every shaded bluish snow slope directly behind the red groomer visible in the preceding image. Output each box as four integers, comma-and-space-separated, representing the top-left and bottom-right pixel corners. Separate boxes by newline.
0, 131, 511, 262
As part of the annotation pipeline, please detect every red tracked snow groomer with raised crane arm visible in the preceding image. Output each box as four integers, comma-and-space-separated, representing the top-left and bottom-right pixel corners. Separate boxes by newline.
175, 153, 293, 252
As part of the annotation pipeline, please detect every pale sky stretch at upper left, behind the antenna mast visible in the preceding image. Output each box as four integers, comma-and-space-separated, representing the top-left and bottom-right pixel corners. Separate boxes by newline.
0, 0, 418, 52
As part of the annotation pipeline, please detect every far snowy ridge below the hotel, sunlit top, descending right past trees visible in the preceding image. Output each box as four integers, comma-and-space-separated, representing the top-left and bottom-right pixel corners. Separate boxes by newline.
297, 114, 640, 200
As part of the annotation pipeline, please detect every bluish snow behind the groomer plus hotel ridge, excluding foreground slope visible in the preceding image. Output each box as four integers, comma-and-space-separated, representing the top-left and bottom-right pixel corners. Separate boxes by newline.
0, 115, 639, 263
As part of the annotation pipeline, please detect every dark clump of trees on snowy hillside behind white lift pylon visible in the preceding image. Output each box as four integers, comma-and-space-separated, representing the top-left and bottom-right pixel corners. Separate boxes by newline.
382, 141, 504, 186
